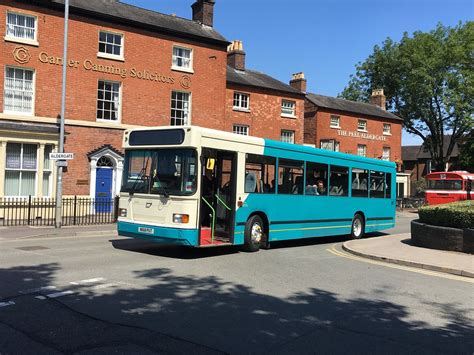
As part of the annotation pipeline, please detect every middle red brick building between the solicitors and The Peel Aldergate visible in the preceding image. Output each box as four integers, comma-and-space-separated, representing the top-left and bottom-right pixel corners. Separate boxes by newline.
225, 41, 305, 144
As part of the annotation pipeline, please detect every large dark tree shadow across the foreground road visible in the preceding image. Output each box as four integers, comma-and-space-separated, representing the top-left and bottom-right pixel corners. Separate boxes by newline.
0, 264, 474, 354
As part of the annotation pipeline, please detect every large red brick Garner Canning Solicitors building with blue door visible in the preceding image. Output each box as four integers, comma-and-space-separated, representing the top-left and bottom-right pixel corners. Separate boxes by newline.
0, 0, 229, 197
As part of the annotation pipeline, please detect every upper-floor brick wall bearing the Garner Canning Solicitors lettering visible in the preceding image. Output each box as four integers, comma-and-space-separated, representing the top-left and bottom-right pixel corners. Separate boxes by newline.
0, 1, 227, 128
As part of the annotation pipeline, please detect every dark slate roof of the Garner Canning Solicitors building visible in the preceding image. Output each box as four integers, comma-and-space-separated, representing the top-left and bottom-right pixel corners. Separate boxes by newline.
29, 0, 229, 46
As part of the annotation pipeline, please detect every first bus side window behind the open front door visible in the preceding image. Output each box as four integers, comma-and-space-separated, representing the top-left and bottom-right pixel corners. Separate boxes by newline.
244, 154, 276, 193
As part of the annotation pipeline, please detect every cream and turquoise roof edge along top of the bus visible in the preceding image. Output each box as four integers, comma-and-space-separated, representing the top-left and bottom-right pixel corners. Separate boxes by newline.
125, 126, 396, 168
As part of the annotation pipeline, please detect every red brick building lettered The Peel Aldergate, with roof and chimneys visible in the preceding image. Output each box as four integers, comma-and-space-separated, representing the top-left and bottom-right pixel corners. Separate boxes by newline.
293, 81, 402, 164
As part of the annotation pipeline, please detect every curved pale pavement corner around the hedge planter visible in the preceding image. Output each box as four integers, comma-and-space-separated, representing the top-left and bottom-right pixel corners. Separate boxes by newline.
342, 233, 474, 278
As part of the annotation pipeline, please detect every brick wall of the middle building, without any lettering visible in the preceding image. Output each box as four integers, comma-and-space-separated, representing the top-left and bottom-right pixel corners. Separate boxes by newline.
225, 84, 304, 144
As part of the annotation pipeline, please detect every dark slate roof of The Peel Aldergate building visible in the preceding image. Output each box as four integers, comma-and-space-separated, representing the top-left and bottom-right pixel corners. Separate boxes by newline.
306, 93, 402, 121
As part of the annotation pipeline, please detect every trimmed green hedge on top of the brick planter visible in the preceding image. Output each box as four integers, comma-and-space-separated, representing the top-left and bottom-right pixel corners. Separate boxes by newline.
418, 200, 474, 229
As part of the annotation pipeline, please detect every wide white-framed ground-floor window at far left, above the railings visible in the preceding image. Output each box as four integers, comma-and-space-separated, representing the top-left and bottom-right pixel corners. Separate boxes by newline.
4, 143, 38, 197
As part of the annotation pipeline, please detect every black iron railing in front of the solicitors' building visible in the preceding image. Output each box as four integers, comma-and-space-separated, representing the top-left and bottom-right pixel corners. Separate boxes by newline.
0, 196, 118, 226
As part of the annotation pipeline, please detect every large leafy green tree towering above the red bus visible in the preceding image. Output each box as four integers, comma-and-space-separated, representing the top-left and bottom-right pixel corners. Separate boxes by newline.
339, 21, 474, 170
